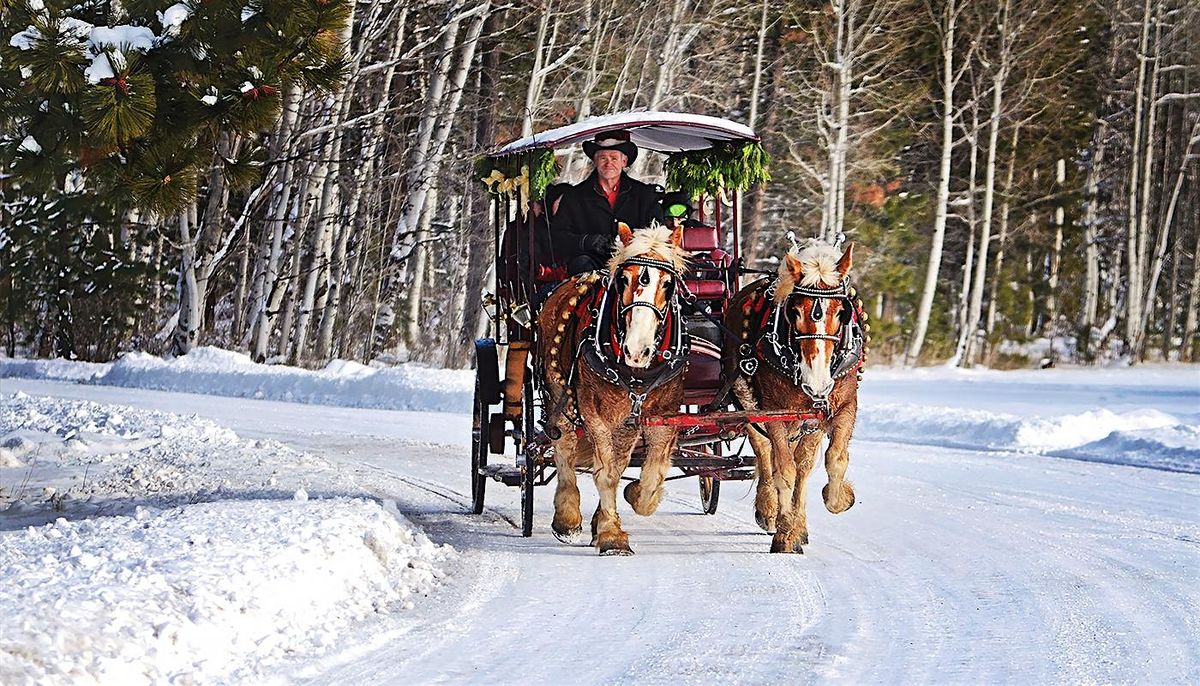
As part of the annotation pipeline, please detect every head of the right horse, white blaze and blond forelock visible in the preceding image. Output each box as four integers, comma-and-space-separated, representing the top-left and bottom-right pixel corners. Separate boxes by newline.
775, 240, 854, 404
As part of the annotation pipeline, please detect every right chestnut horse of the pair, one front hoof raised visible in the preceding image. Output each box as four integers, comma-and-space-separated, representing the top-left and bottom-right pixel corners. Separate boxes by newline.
725, 240, 866, 553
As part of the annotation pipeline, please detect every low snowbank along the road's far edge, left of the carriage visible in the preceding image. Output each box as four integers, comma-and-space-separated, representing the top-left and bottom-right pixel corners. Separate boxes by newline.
0, 348, 475, 413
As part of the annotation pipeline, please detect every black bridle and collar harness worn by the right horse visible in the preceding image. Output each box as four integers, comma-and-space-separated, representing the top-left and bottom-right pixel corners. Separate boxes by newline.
738, 278, 866, 409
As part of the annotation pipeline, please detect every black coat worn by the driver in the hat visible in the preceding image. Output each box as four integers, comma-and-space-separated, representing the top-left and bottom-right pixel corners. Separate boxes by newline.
551, 172, 664, 264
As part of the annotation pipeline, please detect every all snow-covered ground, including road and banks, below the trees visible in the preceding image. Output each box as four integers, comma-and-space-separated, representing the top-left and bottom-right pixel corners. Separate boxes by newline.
0, 350, 1200, 684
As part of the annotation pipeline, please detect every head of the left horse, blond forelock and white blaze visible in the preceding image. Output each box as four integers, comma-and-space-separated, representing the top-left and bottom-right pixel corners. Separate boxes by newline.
608, 223, 688, 369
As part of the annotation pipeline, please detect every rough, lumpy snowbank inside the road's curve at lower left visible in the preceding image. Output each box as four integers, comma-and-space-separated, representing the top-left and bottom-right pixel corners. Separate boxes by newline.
0, 393, 454, 685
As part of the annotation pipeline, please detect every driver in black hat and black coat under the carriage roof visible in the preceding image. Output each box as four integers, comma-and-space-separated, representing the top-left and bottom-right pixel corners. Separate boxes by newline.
553, 131, 662, 275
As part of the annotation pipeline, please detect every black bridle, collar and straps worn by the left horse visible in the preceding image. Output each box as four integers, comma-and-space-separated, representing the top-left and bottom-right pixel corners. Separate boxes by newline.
559, 255, 691, 427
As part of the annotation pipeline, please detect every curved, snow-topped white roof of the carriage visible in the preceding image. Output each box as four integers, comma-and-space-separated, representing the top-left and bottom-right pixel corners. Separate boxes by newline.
492, 112, 758, 157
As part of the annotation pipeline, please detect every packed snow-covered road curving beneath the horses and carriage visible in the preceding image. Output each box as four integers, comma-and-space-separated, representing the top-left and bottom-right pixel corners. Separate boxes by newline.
9, 379, 1200, 684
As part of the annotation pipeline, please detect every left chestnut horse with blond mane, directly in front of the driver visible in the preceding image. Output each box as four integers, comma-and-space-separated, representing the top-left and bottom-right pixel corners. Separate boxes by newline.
536, 224, 688, 555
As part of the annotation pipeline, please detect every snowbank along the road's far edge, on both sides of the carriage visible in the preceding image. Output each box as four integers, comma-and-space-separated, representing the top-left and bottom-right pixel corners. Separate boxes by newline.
0, 348, 1200, 473
